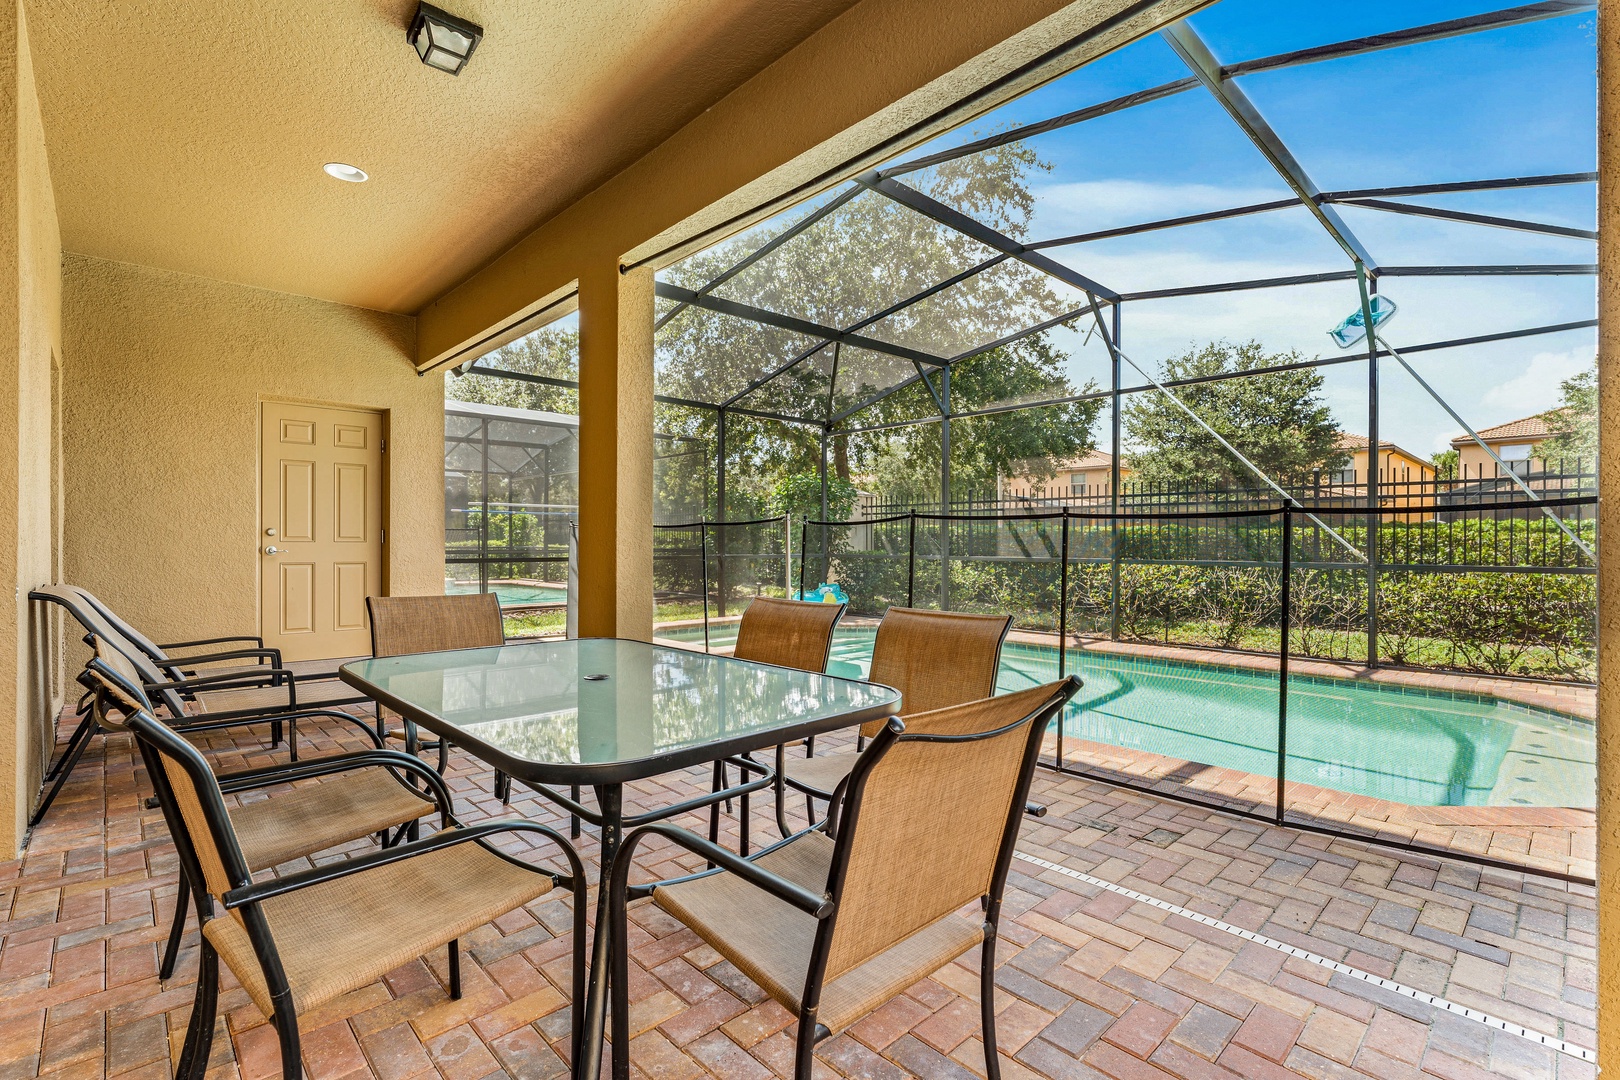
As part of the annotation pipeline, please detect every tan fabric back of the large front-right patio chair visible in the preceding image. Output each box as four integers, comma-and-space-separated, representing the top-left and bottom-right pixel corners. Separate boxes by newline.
812, 675, 1081, 980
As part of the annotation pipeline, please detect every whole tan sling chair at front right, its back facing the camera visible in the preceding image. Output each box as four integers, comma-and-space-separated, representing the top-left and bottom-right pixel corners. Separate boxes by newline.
602, 675, 1081, 1080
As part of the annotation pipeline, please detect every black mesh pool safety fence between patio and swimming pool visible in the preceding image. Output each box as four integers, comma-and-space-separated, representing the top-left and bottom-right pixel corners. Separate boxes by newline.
653, 497, 1597, 884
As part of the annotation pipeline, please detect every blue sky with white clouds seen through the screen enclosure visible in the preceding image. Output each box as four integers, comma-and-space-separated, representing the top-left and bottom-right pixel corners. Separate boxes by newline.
664, 0, 1597, 455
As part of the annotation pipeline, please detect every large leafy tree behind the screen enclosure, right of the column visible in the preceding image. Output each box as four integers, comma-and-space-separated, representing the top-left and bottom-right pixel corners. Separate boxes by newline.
656, 142, 1100, 517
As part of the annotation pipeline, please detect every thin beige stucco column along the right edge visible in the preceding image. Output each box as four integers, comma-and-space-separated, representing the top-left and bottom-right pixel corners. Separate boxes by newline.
1597, 0, 1620, 1072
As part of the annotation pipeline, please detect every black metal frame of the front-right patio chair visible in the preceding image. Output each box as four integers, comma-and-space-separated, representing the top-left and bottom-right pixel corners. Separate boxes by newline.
596, 675, 1081, 1080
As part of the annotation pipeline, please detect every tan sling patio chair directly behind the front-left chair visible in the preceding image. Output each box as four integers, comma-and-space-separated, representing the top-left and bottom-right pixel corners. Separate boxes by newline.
79, 638, 454, 980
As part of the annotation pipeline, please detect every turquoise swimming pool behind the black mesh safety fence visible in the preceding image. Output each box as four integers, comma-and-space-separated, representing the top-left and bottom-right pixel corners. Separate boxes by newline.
659, 623, 1596, 806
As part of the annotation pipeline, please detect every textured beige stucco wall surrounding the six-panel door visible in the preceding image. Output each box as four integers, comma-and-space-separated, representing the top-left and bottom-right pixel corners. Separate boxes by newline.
62, 254, 444, 660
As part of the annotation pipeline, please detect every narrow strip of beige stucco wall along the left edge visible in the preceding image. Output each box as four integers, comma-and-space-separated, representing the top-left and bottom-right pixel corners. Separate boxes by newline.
0, 2, 62, 852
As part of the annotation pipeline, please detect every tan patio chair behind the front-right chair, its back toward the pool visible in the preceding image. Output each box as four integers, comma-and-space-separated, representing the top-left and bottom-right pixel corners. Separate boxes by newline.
776, 607, 1013, 836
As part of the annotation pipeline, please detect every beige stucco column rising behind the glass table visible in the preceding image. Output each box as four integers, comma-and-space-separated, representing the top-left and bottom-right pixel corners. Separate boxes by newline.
580, 259, 653, 641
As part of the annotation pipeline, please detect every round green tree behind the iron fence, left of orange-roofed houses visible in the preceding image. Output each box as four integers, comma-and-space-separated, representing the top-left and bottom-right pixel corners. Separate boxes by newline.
1124, 342, 1349, 491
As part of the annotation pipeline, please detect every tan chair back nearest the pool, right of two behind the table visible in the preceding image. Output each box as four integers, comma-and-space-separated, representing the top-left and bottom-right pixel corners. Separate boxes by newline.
860, 607, 1013, 738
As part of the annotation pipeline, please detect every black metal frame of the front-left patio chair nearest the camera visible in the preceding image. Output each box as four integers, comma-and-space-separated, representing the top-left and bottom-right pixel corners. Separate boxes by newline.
128, 696, 586, 1080
